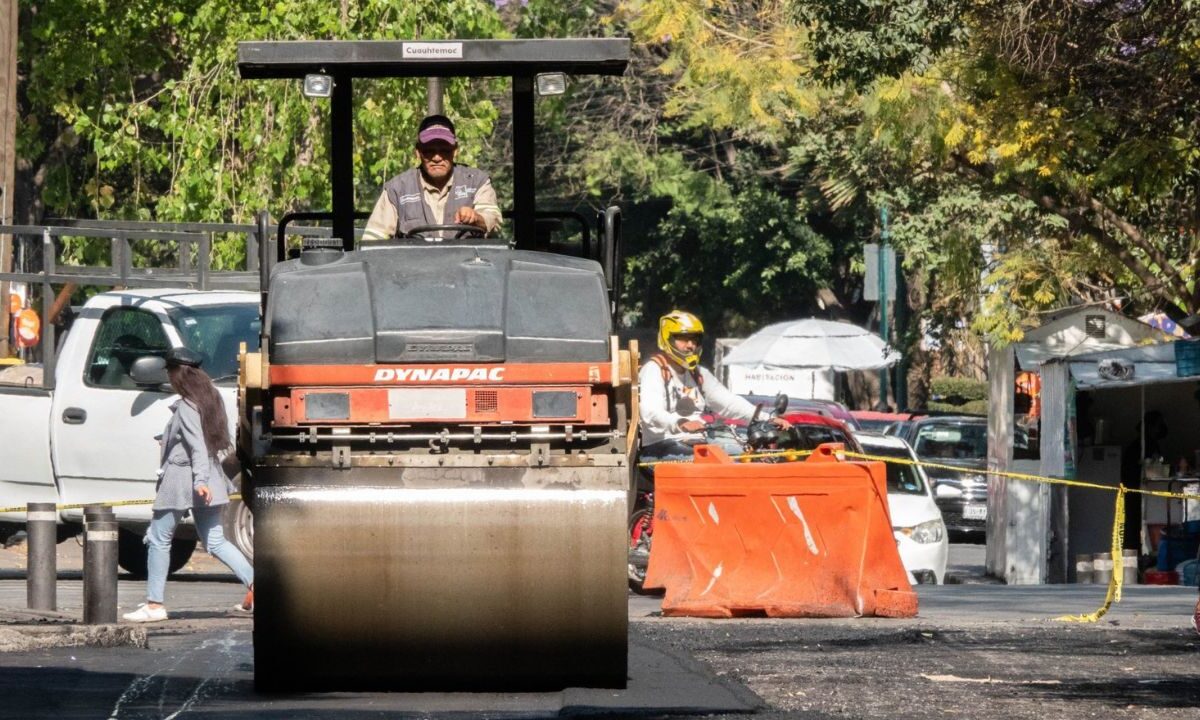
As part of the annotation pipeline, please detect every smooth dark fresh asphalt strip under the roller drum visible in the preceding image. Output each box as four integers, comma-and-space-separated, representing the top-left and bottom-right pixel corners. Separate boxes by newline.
0, 625, 762, 720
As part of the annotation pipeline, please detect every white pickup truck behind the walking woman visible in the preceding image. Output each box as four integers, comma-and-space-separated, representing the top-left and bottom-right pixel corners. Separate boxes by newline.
0, 288, 260, 575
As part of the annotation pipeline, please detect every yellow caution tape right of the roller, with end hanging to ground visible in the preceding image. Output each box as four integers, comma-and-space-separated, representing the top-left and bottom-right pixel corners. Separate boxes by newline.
637, 441, 1200, 623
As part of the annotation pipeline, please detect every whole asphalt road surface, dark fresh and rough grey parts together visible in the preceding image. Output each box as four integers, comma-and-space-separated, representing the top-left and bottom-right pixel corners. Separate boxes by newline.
0, 542, 1200, 720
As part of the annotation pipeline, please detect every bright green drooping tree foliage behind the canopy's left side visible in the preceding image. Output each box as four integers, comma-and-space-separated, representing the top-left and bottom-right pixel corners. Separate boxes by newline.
20, 0, 504, 221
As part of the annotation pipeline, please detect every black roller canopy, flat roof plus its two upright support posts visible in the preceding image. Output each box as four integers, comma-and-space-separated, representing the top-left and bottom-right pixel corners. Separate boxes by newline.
238, 38, 630, 250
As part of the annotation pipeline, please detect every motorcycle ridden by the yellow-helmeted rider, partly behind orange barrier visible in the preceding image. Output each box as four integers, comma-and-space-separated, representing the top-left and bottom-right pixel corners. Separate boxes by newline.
628, 394, 802, 595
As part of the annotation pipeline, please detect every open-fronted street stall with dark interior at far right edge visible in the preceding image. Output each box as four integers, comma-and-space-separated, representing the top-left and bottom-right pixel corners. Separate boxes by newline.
1064, 340, 1200, 584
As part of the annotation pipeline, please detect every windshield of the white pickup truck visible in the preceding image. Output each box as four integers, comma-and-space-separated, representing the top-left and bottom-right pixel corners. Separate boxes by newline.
167, 304, 263, 380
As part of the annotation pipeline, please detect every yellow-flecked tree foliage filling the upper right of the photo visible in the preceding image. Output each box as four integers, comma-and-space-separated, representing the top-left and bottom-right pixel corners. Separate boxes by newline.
625, 0, 1200, 350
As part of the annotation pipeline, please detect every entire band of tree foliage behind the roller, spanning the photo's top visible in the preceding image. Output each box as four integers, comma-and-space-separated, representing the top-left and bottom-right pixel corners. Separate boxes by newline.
18, 0, 1200, 371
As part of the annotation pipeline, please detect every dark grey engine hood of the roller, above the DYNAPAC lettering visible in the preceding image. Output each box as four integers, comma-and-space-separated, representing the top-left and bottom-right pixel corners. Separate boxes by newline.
266, 245, 612, 365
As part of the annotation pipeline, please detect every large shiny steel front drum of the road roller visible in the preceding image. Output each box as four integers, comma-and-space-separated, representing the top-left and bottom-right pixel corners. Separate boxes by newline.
254, 467, 628, 691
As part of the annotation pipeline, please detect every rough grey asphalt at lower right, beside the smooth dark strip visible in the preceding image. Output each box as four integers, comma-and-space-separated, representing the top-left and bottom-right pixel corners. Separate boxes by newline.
644, 620, 1200, 720
